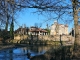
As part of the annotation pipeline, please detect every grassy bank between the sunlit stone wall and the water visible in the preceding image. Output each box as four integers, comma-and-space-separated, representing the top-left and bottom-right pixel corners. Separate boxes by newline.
0, 39, 72, 50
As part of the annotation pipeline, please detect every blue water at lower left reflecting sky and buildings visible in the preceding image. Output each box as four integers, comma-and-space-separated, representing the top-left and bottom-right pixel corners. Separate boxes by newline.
0, 46, 50, 60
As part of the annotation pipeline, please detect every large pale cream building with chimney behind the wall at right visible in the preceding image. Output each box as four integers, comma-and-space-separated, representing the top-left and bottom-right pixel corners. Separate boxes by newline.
50, 21, 68, 35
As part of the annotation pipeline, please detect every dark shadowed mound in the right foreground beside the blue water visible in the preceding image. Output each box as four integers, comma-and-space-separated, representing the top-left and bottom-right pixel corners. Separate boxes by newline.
30, 46, 72, 60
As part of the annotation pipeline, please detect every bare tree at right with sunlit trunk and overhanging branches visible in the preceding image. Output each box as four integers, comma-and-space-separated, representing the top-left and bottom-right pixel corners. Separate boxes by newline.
29, 0, 80, 45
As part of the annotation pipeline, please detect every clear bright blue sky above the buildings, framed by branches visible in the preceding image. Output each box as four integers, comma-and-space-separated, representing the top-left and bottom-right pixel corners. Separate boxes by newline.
14, 9, 73, 31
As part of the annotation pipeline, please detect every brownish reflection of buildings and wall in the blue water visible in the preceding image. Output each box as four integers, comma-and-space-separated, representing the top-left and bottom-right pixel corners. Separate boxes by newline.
21, 46, 51, 54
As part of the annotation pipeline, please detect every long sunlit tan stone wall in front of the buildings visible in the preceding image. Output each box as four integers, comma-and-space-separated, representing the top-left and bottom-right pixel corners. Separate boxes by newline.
14, 35, 74, 42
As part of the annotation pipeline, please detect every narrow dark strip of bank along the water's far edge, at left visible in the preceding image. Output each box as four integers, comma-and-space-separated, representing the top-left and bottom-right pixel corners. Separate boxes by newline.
0, 44, 50, 51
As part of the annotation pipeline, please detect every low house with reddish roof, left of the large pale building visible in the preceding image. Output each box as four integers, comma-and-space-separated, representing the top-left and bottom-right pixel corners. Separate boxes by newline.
15, 26, 48, 35
